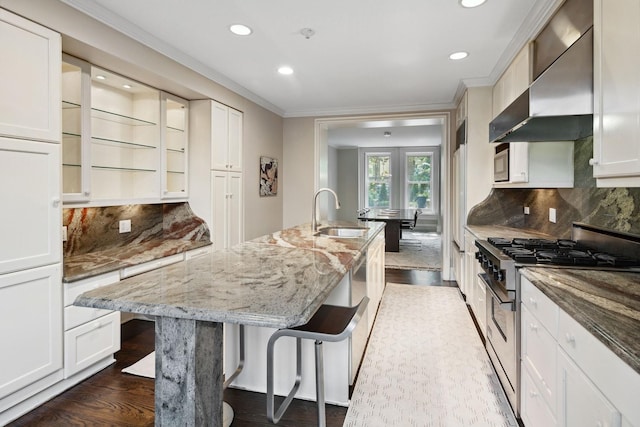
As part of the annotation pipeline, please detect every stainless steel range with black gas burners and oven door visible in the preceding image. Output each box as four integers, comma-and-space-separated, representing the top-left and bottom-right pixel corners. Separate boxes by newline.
476, 223, 640, 416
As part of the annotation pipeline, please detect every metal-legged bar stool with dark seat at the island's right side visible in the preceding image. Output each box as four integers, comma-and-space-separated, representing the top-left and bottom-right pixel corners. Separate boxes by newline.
267, 296, 369, 426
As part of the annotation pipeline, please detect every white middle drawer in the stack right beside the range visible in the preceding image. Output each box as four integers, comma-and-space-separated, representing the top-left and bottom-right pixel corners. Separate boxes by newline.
520, 306, 557, 414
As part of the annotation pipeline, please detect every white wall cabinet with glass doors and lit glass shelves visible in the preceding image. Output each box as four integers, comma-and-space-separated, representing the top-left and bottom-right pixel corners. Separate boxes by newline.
62, 55, 189, 206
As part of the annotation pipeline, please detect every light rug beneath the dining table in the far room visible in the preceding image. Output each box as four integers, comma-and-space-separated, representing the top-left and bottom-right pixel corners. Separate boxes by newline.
384, 231, 442, 271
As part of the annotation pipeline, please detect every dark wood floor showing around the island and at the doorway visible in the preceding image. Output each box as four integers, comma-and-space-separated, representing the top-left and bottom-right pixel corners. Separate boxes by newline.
9, 269, 456, 427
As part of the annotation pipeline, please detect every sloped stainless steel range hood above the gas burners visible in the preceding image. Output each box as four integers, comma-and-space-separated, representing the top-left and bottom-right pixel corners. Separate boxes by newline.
489, 28, 593, 142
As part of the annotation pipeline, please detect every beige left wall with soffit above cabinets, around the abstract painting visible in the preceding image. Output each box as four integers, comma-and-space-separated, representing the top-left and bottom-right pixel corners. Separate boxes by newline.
0, 0, 286, 239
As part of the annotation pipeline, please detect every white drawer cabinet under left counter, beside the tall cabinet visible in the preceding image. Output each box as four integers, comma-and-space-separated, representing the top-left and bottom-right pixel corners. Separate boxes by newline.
64, 271, 120, 378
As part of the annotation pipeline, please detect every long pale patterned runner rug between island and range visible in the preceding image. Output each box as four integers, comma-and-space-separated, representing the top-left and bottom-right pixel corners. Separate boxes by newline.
344, 283, 518, 427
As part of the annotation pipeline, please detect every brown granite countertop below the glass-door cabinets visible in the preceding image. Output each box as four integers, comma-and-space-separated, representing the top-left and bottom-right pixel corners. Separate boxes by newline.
62, 239, 211, 283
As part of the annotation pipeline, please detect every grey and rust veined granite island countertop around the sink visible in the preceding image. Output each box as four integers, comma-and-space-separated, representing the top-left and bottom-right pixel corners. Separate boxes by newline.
74, 223, 384, 328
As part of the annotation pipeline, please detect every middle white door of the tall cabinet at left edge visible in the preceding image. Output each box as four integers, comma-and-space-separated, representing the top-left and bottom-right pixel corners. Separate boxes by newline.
0, 139, 62, 274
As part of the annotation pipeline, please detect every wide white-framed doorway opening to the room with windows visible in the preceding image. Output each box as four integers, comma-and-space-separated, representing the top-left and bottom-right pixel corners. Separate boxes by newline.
315, 112, 451, 280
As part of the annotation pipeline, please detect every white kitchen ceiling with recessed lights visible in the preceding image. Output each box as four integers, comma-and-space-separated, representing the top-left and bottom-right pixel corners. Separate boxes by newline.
62, 0, 561, 117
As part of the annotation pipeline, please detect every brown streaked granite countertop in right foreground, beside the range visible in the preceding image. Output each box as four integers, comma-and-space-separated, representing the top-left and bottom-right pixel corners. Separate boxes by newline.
521, 267, 640, 373
